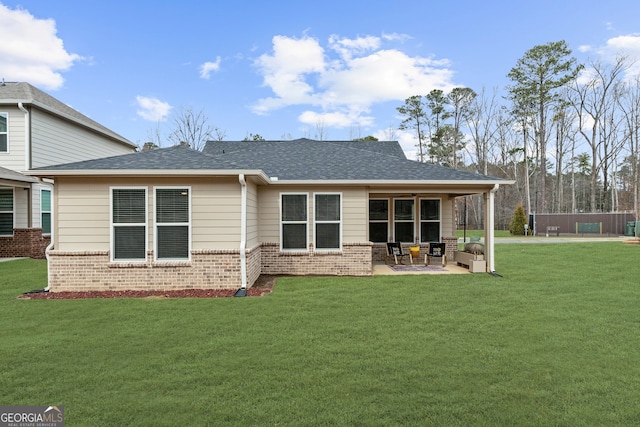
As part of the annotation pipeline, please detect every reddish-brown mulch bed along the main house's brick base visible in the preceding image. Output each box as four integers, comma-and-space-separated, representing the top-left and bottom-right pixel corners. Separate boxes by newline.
18, 275, 276, 299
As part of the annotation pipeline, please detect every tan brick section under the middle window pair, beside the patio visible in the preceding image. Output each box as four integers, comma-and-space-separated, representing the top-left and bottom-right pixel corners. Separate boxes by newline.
262, 242, 373, 276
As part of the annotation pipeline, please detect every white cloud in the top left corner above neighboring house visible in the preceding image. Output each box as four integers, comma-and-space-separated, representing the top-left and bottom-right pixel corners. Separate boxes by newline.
0, 4, 84, 90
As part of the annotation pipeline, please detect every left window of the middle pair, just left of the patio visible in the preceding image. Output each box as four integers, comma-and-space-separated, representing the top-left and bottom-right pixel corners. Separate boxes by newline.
280, 194, 308, 250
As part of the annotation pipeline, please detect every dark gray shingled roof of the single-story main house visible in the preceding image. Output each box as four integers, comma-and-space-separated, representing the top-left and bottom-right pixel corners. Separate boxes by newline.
34, 139, 503, 182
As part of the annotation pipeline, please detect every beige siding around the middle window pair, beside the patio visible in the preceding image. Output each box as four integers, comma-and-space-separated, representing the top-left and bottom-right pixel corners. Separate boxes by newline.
259, 185, 369, 244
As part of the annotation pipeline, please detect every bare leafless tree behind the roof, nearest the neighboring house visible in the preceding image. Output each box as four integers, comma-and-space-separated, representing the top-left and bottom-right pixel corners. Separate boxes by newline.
168, 108, 225, 150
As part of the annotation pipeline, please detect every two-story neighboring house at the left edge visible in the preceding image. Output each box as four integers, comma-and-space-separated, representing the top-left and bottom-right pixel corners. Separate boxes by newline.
0, 82, 136, 258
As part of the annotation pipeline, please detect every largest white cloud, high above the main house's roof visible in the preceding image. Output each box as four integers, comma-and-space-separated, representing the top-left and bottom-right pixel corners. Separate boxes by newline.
252, 34, 454, 127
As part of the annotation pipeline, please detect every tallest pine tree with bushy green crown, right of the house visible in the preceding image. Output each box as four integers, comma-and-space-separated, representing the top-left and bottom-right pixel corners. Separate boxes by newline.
507, 40, 583, 212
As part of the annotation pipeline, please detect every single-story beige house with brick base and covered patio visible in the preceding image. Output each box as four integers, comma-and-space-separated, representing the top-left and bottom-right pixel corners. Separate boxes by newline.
30, 139, 511, 291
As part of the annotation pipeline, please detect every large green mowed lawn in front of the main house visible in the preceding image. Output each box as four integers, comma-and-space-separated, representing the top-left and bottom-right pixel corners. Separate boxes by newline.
0, 242, 640, 426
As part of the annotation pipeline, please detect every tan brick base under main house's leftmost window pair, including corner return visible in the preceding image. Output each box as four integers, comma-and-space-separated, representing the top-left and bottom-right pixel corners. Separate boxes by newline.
49, 247, 260, 292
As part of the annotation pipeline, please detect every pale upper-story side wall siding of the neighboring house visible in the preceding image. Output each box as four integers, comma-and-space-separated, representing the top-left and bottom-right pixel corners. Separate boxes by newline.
31, 109, 133, 168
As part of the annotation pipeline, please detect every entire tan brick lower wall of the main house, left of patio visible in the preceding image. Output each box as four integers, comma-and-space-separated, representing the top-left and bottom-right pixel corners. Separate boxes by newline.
49, 242, 373, 292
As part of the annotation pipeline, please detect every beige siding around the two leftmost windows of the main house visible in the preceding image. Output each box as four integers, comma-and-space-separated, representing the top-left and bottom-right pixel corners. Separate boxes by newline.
54, 177, 240, 251
